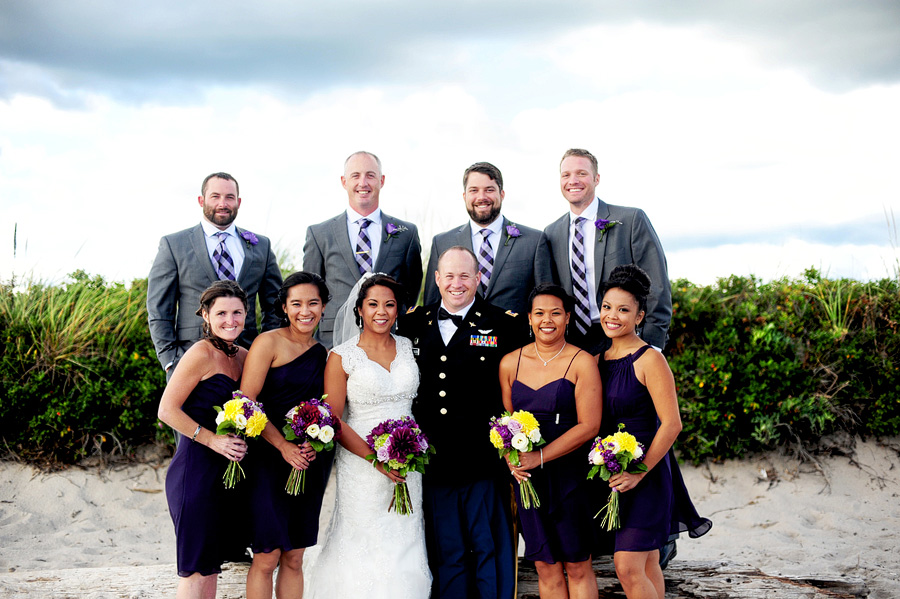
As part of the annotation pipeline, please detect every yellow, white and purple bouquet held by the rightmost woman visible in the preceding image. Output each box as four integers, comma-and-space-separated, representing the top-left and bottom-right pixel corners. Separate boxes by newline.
588, 424, 647, 530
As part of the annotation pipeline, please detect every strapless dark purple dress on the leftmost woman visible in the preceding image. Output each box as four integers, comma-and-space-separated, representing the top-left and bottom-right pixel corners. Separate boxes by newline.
166, 373, 246, 576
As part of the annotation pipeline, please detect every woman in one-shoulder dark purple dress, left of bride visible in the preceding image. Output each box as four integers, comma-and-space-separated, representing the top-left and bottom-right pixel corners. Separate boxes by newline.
241, 272, 333, 599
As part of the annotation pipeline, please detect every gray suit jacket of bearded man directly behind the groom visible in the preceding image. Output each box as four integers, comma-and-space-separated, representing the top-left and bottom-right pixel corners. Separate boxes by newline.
423, 217, 550, 314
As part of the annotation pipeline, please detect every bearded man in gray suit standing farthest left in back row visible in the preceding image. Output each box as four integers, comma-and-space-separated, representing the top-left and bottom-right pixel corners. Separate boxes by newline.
147, 173, 281, 378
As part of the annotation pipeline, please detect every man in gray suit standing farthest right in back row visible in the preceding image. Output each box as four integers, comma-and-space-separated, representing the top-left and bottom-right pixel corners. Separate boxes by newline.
537, 149, 672, 354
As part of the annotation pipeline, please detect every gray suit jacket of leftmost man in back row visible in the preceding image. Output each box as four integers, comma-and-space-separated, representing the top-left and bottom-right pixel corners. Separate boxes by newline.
147, 224, 281, 368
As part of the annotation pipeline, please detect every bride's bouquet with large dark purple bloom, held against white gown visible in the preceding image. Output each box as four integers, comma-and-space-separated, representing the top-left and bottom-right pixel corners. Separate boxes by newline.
366, 416, 435, 516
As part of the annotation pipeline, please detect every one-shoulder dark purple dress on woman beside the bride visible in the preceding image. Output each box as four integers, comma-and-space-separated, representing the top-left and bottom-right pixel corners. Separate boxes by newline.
244, 344, 334, 553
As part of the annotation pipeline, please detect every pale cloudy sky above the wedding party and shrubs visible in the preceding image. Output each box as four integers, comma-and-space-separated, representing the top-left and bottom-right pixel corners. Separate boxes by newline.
0, 0, 900, 283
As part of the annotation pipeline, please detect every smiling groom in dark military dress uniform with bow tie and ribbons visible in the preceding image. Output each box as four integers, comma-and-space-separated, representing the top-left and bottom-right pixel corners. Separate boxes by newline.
398, 246, 527, 599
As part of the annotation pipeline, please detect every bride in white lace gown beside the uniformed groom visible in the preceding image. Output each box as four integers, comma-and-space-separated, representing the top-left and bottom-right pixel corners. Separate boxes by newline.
304, 275, 431, 599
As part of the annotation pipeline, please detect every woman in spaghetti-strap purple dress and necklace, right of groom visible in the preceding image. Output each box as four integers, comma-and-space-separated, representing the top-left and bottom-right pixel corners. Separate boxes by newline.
500, 284, 601, 599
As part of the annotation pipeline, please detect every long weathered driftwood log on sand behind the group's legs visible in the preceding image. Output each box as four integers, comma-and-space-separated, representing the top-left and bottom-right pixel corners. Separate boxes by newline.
0, 558, 869, 599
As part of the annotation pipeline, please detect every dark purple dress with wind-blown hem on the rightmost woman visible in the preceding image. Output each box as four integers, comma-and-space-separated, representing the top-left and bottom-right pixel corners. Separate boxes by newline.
598, 345, 712, 551
